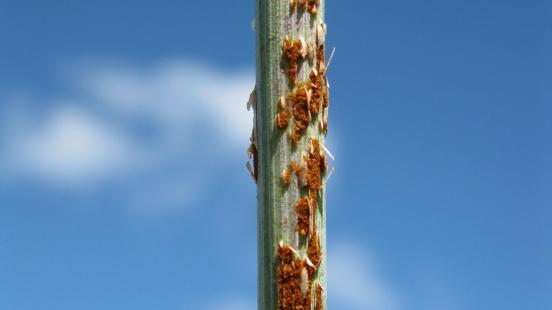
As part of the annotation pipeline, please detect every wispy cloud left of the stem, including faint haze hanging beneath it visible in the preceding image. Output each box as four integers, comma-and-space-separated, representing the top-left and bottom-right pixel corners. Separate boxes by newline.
0, 60, 254, 210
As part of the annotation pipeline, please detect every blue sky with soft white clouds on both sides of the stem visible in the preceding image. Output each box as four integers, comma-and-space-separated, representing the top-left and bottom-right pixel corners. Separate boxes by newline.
0, 0, 552, 310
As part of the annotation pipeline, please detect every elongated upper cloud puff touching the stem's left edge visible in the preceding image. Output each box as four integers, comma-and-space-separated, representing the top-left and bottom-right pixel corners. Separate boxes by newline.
76, 61, 254, 145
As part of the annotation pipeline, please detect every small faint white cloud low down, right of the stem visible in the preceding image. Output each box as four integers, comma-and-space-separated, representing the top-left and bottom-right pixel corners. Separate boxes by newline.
328, 242, 402, 310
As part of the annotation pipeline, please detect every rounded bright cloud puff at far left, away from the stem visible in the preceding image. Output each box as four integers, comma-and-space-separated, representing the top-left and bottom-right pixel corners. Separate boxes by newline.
3, 106, 139, 183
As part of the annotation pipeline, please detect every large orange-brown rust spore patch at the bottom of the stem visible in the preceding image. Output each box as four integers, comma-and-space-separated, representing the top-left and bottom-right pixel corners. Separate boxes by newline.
277, 245, 312, 310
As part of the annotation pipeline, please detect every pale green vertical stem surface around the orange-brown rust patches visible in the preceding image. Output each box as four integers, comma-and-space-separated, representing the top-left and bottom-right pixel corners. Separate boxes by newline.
255, 0, 326, 310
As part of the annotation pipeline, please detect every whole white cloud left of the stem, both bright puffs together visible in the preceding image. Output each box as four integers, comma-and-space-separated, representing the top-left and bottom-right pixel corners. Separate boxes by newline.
0, 61, 254, 186
